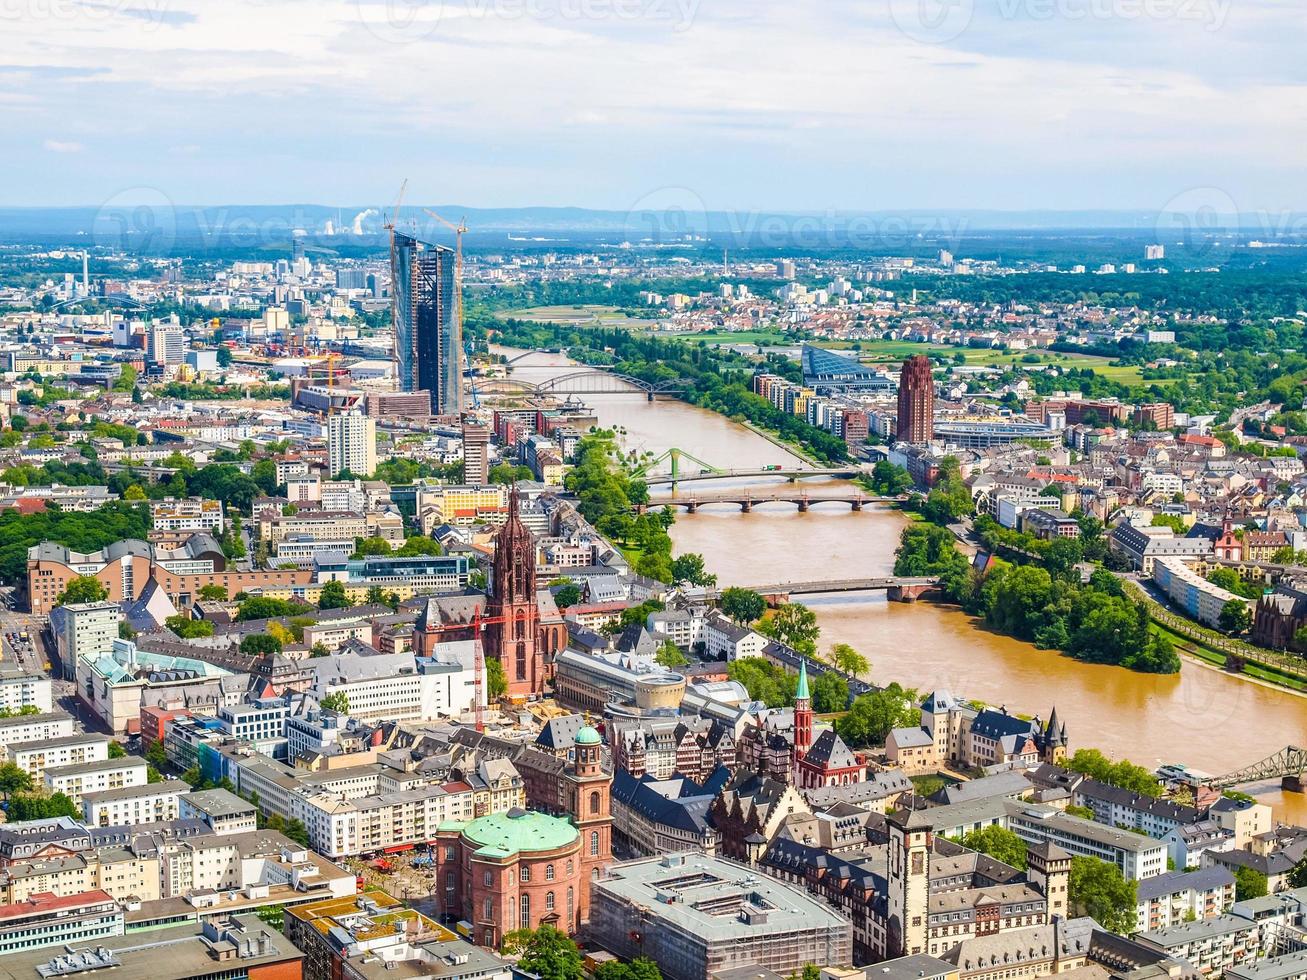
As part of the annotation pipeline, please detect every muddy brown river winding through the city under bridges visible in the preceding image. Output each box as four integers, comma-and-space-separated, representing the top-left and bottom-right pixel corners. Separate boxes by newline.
496, 354, 1307, 823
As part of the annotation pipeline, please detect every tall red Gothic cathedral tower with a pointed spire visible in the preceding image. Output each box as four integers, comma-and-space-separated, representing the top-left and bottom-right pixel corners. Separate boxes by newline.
485, 487, 545, 698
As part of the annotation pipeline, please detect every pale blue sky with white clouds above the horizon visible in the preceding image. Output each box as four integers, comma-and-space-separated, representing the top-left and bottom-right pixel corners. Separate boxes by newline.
0, 0, 1307, 212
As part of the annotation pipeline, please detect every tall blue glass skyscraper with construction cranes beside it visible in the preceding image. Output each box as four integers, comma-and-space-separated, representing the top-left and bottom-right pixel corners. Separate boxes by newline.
393, 231, 463, 416
